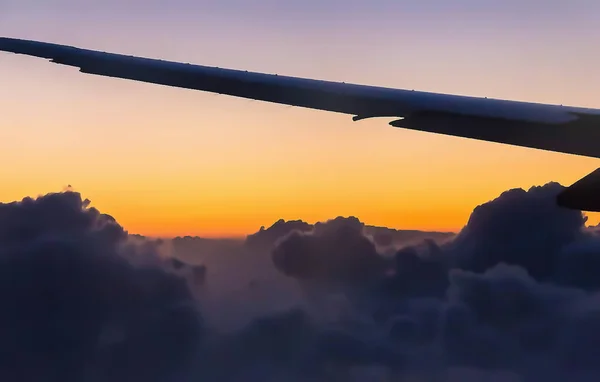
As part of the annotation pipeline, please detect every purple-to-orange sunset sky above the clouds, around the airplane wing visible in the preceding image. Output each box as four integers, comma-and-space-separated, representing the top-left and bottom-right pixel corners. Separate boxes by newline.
0, 0, 600, 236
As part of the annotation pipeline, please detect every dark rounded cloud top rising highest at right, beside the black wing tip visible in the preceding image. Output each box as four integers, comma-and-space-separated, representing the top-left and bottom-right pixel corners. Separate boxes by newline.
451, 183, 586, 280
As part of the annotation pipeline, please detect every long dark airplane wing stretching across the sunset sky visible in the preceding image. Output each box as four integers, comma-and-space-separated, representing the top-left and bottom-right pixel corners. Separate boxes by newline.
0, 38, 600, 158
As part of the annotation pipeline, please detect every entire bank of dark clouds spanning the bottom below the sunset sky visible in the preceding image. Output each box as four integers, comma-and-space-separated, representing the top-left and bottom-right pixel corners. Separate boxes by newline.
0, 183, 600, 382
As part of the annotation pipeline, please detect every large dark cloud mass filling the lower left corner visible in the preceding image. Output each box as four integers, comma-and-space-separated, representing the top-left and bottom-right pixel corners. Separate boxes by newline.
0, 192, 202, 381
